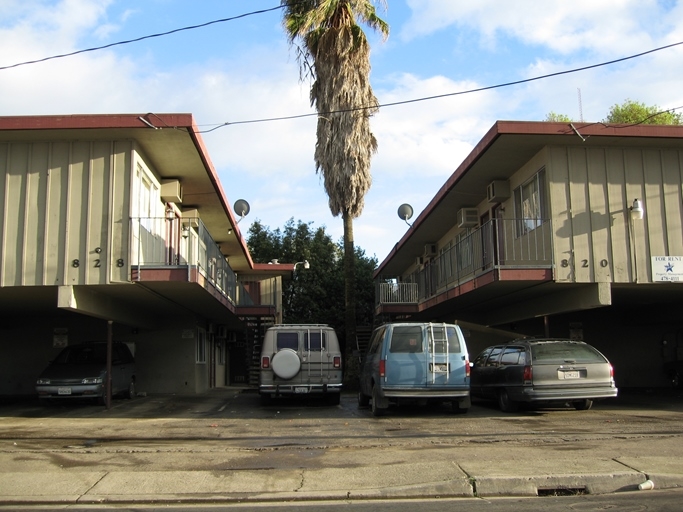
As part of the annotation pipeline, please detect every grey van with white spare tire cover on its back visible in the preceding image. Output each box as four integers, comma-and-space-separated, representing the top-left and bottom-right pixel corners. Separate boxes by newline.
259, 324, 342, 405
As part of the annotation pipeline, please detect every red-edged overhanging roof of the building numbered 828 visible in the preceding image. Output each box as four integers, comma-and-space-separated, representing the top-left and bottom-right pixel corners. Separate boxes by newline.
0, 113, 293, 275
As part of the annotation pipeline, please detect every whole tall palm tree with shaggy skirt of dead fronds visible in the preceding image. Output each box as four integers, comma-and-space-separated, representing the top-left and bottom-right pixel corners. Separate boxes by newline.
282, 0, 389, 380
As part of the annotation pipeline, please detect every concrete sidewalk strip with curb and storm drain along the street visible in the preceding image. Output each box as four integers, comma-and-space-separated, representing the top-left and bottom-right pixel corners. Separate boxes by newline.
0, 457, 683, 505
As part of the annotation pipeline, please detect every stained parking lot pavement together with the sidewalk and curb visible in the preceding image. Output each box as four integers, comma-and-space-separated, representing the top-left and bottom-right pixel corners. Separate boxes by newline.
0, 388, 683, 503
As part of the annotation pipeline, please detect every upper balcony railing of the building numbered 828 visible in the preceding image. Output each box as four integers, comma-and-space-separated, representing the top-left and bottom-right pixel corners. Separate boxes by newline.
131, 217, 278, 306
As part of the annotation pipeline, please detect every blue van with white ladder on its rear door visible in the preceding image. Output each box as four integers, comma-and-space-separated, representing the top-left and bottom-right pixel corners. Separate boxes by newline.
358, 323, 471, 416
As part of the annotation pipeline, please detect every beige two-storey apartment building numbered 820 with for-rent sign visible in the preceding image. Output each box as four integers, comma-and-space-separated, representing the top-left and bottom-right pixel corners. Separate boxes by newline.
375, 121, 683, 388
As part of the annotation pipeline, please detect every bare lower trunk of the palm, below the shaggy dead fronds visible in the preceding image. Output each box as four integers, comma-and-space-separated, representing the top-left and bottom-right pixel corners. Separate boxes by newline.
342, 210, 358, 386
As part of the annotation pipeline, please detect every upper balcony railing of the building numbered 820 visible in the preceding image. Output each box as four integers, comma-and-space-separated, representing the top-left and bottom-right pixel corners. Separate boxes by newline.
376, 219, 553, 304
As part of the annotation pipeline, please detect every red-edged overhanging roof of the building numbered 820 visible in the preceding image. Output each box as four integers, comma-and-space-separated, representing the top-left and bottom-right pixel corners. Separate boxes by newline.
374, 121, 683, 277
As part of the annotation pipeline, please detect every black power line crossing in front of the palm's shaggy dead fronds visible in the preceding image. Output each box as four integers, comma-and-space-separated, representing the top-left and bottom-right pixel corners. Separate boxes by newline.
194, 41, 683, 133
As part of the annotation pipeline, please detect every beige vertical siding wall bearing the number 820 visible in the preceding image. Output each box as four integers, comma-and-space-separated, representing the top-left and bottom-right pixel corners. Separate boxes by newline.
546, 147, 683, 283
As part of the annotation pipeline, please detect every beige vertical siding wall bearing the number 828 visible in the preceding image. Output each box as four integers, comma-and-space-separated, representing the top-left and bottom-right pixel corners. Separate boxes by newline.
0, 141, 132, 286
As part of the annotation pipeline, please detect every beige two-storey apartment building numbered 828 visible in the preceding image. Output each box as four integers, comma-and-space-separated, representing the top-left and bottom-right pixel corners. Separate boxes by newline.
0, 114, 293, 395
